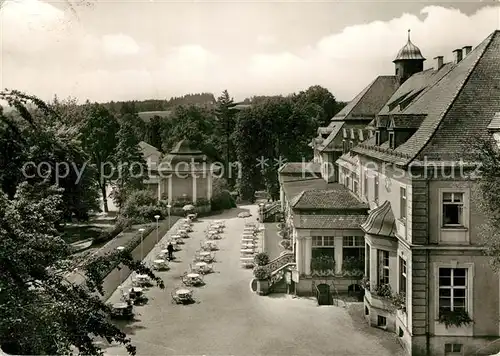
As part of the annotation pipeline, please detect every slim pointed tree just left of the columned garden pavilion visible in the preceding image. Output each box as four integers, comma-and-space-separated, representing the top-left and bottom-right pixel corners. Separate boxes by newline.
112, 115, 148, 208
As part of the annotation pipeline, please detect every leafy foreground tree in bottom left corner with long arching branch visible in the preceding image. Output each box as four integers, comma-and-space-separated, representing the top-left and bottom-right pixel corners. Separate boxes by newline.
0, 182, 164, 355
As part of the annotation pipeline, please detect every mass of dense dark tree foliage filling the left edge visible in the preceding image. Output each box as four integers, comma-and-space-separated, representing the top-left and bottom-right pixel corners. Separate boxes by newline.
0, 91, 164, 355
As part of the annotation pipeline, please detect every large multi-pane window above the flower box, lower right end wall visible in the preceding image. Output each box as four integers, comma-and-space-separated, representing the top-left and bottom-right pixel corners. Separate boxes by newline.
439, 268, 467, 310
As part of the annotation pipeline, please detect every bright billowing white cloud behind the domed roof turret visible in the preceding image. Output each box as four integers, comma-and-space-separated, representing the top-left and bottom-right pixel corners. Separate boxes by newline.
249, 6, 500, 100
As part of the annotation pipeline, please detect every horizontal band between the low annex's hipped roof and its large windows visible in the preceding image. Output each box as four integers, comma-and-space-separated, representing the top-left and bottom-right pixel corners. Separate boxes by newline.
294, 214, 366, 229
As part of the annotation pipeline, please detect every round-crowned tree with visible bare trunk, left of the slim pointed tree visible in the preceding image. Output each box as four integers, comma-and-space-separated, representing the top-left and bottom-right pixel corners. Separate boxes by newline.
81, 103, 120, 212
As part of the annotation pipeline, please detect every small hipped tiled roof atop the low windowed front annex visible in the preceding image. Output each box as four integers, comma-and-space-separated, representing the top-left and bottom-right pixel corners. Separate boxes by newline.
290, 183, 368, 210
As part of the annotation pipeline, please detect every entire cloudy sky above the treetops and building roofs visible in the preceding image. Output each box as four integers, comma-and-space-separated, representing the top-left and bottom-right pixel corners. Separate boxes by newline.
0, 0, 500, 102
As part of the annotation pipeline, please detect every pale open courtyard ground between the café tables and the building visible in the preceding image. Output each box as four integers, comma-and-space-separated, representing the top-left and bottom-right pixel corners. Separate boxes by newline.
105, 206, 401, 356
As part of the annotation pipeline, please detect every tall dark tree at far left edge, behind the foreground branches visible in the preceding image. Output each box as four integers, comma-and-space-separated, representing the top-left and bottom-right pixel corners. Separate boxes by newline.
0, 90, 99, 220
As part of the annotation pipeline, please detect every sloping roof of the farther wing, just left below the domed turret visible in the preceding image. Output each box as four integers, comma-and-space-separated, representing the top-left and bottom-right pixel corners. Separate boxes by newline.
332, 75, 399, 121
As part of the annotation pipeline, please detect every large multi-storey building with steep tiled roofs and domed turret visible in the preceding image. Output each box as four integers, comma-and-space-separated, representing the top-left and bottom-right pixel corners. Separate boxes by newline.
276, 31, 500, 355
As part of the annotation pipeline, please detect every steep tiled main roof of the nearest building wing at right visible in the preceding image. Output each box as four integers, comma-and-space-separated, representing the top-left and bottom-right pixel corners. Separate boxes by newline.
353, 31, 500, 166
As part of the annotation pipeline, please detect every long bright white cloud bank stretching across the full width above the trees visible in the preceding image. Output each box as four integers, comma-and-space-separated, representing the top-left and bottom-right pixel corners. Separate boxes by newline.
0, 0, 500, 101
